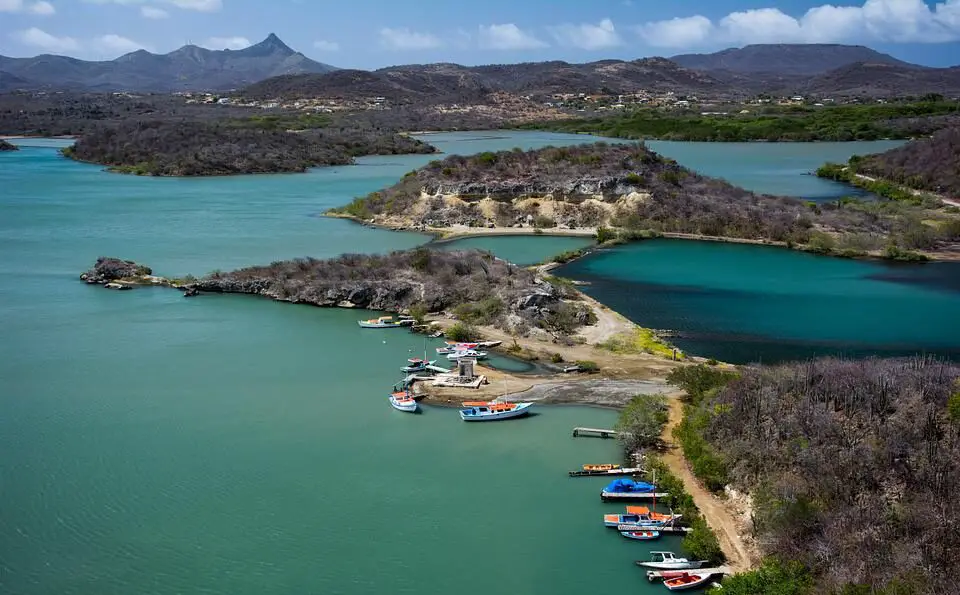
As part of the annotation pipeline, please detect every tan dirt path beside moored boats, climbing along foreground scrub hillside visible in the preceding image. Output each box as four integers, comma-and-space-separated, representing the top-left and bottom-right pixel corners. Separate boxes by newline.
662, 395, 759, 572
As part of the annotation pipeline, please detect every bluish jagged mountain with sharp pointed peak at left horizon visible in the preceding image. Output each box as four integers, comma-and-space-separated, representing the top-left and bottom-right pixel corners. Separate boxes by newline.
0, 33, 335, 92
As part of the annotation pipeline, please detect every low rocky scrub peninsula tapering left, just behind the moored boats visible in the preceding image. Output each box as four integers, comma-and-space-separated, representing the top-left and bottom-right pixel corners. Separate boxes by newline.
80, 247, 596, 335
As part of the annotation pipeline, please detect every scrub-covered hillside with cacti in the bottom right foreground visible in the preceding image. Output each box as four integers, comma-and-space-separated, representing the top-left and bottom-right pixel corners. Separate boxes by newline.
678, 357, 960, 595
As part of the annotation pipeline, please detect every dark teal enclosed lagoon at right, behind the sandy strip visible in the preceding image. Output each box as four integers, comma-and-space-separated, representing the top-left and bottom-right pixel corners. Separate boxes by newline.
557, 240, 960, 362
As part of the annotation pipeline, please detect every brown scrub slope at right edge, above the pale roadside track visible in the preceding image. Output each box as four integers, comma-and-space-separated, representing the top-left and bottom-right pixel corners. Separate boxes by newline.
856, 127, 960, 197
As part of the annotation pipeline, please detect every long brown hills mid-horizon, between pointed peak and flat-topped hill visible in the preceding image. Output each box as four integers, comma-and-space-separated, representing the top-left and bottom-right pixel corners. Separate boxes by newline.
244, 58, 731, 101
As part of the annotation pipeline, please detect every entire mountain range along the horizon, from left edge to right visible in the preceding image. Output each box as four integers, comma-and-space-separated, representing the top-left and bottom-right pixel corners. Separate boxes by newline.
0, 34, 960, 102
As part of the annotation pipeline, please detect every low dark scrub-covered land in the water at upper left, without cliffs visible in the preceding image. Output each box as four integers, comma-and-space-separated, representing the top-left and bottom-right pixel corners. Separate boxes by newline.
63, 120, 436, 176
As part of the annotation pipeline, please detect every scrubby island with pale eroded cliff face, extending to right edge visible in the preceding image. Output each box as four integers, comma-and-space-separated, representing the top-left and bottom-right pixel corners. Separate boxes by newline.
329, 143, 960, 258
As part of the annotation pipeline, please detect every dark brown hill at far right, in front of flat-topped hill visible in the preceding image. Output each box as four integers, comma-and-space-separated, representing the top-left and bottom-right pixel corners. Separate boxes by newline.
797, 63, 960, 97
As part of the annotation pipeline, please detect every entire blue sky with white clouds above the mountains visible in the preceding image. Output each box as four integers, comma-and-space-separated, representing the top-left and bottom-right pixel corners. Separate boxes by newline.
0, 0, 960, 68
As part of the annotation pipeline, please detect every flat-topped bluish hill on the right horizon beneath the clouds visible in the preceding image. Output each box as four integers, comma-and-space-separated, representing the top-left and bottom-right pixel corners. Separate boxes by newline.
670, 43, 914, 76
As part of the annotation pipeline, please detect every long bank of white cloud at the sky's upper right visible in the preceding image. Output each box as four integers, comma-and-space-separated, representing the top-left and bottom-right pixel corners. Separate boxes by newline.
638, 0, 960, 47
